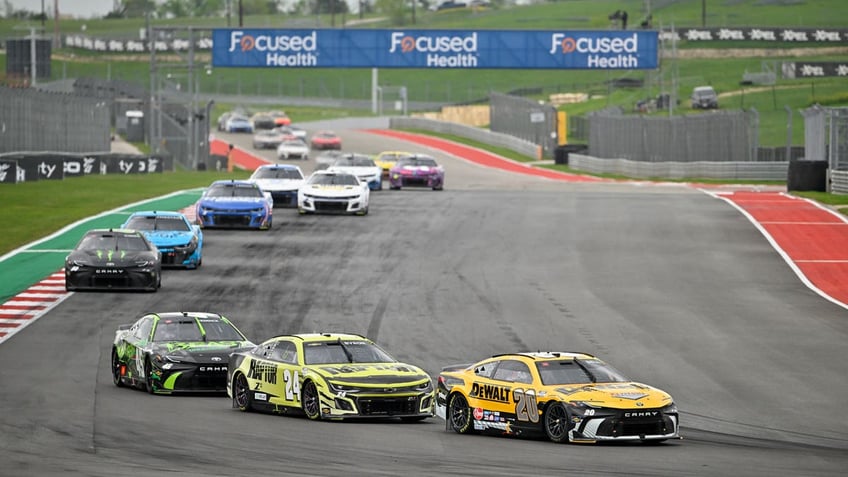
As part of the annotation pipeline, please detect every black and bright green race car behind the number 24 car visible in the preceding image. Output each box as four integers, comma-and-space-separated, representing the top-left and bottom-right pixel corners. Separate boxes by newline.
112, 312, 256, 394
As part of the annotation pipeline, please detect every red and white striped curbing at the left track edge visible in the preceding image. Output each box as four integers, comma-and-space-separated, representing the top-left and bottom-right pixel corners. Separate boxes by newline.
0, 270, 71, 343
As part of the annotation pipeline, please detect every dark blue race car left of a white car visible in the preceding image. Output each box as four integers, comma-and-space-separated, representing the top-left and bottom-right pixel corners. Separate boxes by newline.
196, 180, 274, 230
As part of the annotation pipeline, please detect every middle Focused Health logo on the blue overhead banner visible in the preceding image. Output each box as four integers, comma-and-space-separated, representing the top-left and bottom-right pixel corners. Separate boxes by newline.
389, 31, 478, 68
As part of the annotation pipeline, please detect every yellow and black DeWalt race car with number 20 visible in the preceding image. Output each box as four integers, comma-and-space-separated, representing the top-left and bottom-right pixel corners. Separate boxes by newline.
436, 352, 679, 443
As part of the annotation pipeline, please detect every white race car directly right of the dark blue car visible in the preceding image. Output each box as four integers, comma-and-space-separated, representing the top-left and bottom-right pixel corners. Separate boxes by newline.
297, 169, 371, 215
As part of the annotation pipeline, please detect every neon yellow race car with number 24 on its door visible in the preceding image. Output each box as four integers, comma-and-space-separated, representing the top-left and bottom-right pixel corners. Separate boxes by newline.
227, 333, 435, 421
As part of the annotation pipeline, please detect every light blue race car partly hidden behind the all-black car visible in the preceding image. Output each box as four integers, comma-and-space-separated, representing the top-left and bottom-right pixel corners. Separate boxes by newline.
121, 210, 203, 268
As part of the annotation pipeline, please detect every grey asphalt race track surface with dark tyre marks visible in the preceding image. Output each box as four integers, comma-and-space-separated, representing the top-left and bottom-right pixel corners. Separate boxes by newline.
0, 121, 848, 476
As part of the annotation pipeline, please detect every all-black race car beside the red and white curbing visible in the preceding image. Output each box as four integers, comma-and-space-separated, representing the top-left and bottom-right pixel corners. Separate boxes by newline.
65, 229, 162, 292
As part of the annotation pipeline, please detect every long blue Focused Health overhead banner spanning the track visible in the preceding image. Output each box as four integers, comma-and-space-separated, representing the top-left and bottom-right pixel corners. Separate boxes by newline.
212, 29, 658, 70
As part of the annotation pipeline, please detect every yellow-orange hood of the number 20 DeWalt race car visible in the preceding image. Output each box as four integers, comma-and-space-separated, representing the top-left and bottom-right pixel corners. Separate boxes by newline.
550, 382, 672, 409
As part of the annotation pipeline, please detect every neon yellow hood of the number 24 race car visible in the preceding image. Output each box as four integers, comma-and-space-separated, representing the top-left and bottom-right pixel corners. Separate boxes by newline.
310, 363, 430, 386
